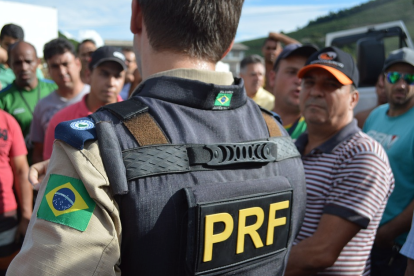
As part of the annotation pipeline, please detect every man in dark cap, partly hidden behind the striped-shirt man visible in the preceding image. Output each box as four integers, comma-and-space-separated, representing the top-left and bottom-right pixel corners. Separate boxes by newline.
269, 43, 317, 140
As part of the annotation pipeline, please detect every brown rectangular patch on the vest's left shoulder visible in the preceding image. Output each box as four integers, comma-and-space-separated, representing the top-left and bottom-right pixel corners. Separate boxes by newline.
124, 112, 169, 147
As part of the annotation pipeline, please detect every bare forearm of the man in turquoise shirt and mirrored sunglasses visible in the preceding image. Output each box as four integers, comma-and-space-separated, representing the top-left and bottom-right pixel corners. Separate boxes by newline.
375, 200, 414, 248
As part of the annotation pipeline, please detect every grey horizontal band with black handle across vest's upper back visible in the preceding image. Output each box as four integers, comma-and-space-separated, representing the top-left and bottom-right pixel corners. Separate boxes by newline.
123, 136, 300, 180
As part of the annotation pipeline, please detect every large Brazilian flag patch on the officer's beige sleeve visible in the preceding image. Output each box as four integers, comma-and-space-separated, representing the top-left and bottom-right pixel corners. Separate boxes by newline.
37, 174, 96, 232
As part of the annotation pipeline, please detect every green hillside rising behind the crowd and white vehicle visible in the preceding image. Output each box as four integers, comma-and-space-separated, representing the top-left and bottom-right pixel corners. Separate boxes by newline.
241, 0, 414, 55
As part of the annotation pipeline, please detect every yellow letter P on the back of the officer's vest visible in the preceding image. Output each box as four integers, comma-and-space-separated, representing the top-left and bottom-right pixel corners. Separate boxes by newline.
203, 213, 234, 262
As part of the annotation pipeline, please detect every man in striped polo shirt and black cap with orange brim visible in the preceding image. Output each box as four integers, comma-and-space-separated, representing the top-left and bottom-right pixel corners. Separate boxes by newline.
285, 47, 393, 276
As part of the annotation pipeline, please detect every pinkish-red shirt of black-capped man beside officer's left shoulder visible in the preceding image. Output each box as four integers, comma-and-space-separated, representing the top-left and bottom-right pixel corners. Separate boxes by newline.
43, 94, 122, 160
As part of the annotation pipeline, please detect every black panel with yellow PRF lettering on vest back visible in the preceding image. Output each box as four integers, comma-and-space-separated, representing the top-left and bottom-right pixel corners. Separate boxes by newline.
184, 176, 292, 275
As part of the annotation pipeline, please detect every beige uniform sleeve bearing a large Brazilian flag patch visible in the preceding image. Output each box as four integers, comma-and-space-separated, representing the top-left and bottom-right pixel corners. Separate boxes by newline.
7, 141, 121, 276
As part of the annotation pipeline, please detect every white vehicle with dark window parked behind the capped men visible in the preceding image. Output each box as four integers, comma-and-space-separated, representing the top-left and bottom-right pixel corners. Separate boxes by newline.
325, 21, 414, 113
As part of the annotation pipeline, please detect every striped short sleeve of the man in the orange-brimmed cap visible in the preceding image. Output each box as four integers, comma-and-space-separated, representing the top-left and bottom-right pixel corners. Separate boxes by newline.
324, 150, 394, 229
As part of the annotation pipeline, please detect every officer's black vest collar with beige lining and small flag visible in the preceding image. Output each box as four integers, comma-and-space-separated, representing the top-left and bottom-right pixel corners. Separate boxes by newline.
132, 69, 247, 110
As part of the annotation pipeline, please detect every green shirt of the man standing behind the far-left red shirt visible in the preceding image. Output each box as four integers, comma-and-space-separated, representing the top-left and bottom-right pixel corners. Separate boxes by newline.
0, 79, 57, 137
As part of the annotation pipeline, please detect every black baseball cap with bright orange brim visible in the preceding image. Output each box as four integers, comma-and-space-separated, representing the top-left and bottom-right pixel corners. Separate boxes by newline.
298, 46, 359, 86
